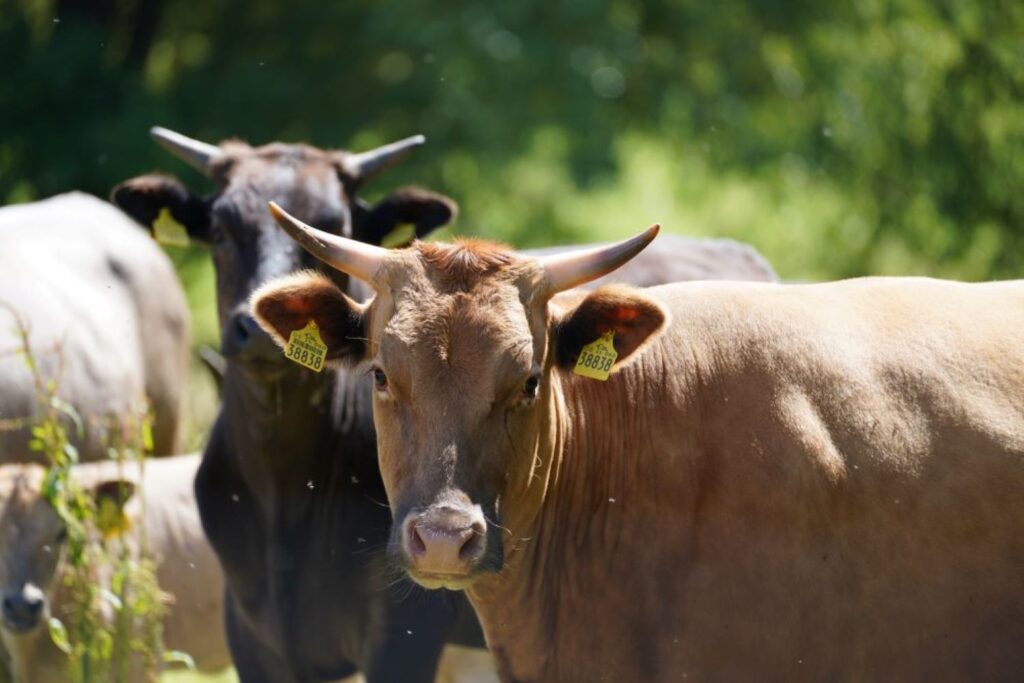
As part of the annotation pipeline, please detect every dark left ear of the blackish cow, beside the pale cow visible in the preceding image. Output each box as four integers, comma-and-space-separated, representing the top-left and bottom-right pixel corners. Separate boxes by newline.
111, 175, 210, 242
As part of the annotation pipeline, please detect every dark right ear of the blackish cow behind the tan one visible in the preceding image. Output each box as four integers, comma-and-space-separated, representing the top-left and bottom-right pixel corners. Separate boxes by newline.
353, 187, 459, 245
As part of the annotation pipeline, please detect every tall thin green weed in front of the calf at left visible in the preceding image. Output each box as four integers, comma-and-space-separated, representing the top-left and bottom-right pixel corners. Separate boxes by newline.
3, 311, 171, 683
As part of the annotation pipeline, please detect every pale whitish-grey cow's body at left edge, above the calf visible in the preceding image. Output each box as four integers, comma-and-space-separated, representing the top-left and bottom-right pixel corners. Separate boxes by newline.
0, 193, 189, 463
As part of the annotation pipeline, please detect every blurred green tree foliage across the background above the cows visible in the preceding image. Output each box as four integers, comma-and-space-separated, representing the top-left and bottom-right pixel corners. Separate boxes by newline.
0, 0, 1024, 279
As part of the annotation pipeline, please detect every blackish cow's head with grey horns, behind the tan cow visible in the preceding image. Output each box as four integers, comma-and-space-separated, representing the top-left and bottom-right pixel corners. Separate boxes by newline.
111, 128, 456, 375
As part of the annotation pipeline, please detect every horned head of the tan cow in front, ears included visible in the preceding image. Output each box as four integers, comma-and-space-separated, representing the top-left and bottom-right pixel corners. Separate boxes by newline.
253, 208, 666, 589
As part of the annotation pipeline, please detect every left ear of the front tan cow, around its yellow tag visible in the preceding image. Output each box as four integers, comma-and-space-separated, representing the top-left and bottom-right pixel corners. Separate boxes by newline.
249, 271, 367, 362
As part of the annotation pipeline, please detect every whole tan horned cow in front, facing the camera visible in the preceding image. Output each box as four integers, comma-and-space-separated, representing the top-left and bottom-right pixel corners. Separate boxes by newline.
247, 204, 1024, 681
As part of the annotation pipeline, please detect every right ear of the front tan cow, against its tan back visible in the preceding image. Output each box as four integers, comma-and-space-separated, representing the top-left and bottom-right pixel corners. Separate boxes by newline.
552, 285, 668, 370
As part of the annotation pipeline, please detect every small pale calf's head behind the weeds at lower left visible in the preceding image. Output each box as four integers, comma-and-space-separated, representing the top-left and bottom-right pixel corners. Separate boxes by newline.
0, 466, 134, 634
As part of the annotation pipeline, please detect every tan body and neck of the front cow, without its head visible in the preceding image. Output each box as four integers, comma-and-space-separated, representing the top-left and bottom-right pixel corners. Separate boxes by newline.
470, 280, 1024, 681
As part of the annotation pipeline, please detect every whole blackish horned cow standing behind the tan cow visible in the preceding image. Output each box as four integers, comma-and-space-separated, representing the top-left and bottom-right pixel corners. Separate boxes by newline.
113, 128, 482, 683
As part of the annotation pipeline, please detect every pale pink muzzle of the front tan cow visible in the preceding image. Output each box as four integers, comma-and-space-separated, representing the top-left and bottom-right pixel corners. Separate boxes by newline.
402, 506, 487, 577
